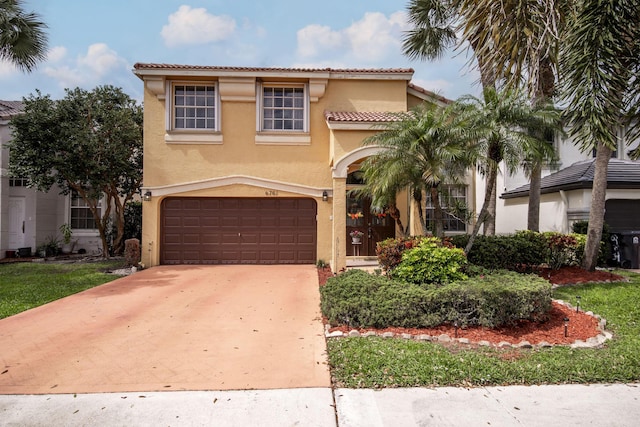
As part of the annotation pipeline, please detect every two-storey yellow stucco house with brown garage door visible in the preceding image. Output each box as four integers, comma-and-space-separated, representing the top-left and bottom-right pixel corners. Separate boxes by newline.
134, 63, 460, 271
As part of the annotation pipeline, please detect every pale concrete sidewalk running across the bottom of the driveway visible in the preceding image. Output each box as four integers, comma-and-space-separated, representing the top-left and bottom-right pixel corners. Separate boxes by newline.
0, 384, 640, 427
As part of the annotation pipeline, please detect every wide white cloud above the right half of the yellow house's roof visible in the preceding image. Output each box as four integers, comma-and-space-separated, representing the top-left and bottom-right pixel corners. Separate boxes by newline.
297, 12, 409, 63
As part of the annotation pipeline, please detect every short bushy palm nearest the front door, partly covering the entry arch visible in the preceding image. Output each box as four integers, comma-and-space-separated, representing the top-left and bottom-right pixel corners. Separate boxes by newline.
361, 104, 473, 237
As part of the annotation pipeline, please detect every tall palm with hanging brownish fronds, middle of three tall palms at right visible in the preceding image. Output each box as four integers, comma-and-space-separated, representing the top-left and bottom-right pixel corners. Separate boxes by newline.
460, 0, 573, 231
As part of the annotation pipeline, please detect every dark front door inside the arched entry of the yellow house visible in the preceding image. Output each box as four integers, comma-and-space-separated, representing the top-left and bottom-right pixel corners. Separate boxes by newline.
345, 196, 395, 256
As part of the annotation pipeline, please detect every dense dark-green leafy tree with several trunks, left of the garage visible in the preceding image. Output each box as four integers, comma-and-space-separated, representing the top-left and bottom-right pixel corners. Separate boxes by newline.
9, 86, 142, 256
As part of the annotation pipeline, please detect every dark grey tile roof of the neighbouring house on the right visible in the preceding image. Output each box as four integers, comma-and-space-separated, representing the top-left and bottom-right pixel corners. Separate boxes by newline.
500, 159, 640, 199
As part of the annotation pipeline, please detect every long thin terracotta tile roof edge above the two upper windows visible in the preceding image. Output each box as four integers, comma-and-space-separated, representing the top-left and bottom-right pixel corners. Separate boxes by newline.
133, 62, 414, 74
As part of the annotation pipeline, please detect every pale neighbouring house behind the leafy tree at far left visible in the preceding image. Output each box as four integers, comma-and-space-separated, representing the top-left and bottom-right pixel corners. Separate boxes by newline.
0, 101, 101, 258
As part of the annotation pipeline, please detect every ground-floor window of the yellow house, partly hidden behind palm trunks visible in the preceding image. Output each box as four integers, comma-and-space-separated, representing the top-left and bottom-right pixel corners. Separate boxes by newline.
425, 185, 467, 232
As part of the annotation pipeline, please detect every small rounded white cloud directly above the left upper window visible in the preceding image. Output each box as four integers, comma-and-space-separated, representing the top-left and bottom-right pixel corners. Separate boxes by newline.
160, 5, 236, 47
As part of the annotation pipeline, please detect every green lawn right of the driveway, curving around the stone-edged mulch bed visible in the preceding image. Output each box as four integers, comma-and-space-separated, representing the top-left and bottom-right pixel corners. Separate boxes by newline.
328, 272, 640, 388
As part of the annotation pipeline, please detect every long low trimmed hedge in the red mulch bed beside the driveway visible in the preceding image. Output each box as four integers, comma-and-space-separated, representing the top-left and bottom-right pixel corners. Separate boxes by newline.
320, 270, 551, 328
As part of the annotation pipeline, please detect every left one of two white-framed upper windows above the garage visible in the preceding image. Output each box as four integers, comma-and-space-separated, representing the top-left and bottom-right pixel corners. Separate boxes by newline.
172, 84, 217, 130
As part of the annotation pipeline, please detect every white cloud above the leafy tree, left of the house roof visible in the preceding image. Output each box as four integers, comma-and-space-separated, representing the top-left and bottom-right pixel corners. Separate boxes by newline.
44, 43, 130, 88
